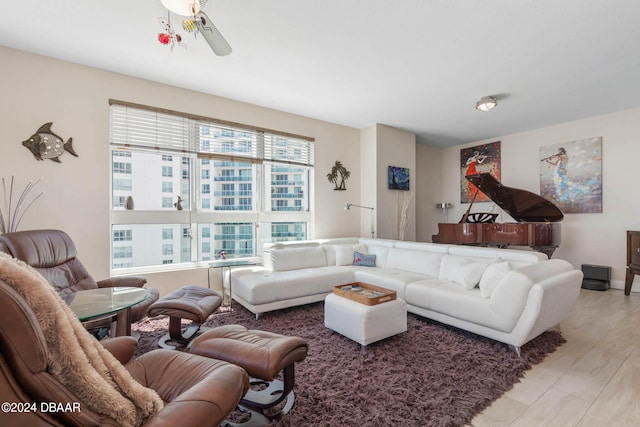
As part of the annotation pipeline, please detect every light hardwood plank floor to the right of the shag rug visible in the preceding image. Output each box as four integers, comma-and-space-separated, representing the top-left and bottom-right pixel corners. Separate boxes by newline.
472, 289, 640, 427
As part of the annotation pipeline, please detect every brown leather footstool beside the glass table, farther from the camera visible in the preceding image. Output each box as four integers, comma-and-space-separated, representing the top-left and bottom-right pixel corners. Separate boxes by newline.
147, 286, 222, 349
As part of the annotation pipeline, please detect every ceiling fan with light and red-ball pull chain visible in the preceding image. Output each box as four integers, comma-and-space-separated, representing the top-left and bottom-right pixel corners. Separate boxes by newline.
158, 0, 231, 56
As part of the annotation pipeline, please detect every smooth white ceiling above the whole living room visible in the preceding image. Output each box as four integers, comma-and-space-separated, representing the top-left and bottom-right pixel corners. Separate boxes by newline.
0, 0, 640, 146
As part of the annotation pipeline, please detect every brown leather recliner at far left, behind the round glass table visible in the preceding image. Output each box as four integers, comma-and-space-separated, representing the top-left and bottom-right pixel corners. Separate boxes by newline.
0, 230, 160, 326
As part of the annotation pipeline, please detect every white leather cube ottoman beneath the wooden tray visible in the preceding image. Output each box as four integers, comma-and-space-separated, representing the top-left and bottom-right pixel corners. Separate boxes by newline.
324, 293, 407, 345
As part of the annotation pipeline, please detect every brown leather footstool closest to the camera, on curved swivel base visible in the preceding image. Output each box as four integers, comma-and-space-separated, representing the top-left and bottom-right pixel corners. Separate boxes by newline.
189, 325, 309, 426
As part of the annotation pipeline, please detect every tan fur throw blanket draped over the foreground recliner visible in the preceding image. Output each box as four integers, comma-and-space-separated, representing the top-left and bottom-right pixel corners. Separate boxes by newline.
0, 252, 163, 426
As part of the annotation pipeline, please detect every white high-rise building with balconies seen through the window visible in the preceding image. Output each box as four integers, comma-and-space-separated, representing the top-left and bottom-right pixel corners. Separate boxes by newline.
112, 129, 309, 269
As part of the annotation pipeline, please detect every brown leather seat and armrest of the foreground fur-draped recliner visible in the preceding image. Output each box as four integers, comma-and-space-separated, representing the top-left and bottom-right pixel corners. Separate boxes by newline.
126, 350, 249, 427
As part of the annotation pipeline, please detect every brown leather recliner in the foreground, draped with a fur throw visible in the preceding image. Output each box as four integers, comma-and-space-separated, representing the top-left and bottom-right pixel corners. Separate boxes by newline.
0, 272, 249, 427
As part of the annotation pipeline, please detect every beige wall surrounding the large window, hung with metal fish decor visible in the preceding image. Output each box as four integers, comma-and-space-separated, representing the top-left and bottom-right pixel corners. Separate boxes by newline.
0, 47, 360, 291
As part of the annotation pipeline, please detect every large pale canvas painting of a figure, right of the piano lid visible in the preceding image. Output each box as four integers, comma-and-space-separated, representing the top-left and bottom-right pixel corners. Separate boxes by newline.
540, 137, 602, 213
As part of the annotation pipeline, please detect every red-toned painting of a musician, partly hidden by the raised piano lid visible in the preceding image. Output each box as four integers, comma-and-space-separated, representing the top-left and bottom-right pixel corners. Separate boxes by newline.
460, 141, 502, 203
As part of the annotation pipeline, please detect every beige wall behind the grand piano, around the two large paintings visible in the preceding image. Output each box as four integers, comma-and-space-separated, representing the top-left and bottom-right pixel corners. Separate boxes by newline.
428, 109, 640, 290
